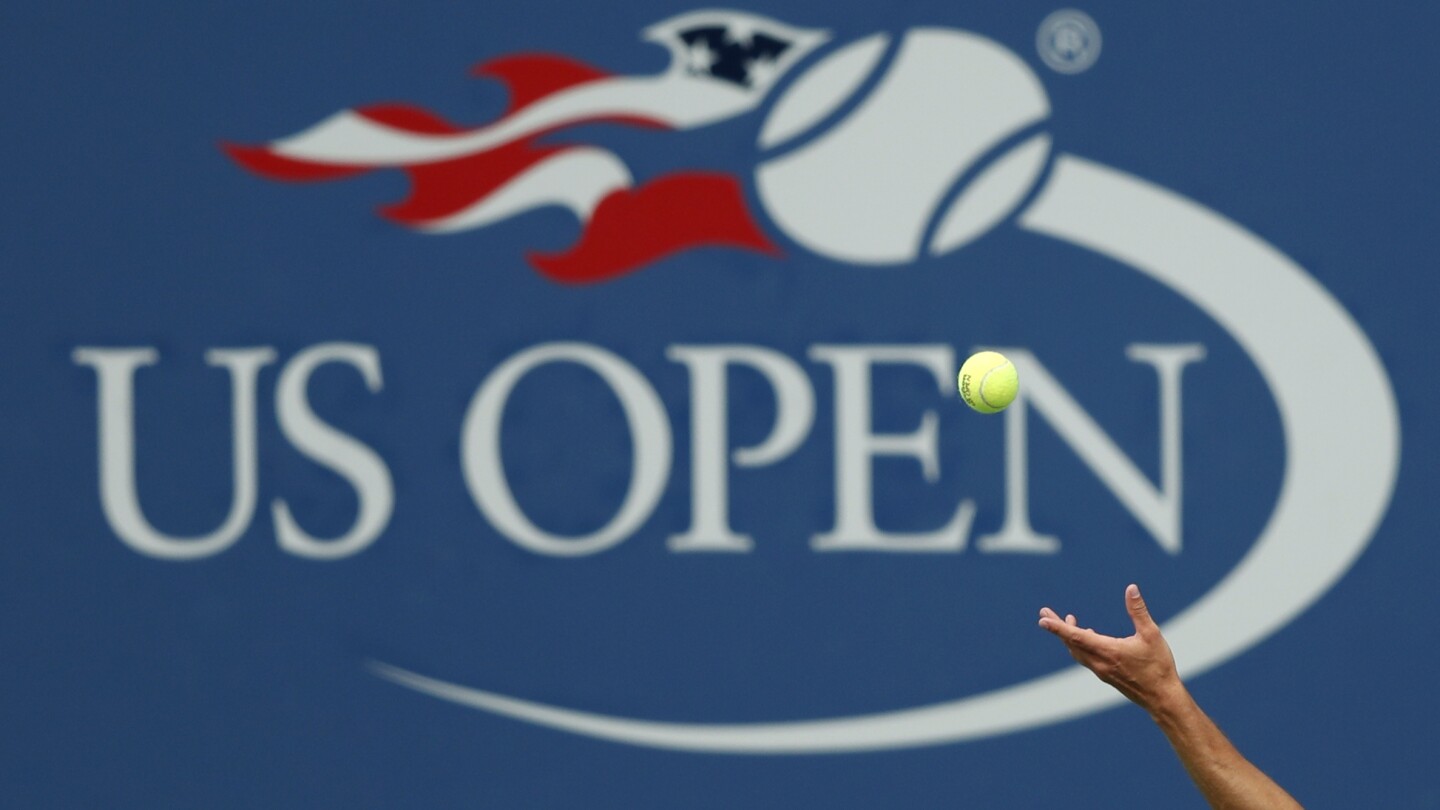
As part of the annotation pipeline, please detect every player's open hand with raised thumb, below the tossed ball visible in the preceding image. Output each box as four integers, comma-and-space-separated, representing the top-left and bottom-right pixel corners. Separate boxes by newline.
1040, 585, 1184, 712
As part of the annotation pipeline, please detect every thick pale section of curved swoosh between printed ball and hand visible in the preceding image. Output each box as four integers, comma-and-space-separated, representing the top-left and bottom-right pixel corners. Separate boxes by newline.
1021, 156, 1400, 675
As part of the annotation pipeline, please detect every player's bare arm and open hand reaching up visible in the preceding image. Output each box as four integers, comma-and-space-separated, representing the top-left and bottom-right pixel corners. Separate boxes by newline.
1040, 585, 1300, 810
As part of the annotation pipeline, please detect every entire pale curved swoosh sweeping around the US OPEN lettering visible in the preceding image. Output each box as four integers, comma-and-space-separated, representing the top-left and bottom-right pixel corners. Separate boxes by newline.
370, 156, 1400, 754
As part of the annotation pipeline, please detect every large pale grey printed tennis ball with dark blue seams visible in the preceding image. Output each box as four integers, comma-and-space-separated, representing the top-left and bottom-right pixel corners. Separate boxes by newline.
756, 29, 1050, 264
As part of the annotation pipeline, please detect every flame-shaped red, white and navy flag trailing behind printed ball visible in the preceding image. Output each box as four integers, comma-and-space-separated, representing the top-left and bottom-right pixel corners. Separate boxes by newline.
223, 12, 828, 282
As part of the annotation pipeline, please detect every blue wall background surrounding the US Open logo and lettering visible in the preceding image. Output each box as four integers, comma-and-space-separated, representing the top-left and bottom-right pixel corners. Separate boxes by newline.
0, 0, 1440, 807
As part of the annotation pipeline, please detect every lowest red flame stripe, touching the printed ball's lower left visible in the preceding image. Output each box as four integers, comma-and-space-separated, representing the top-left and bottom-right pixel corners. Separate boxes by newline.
528, 172, 780, 284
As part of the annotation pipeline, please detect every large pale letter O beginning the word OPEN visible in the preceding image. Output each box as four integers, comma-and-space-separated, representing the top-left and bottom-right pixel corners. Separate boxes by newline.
461, 343, 671, 556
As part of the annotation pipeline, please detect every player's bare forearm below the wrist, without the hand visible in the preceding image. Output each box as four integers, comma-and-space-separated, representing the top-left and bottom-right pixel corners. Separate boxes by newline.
1146, 682, 1300, 810
